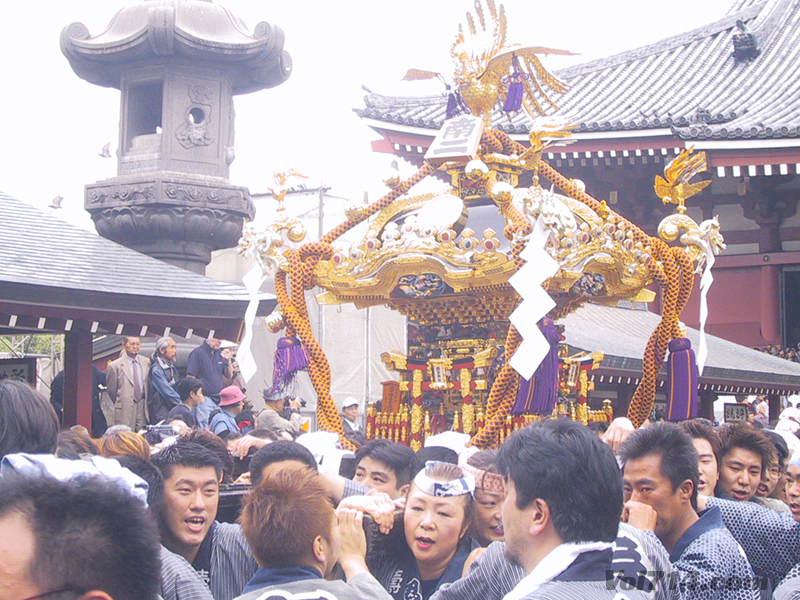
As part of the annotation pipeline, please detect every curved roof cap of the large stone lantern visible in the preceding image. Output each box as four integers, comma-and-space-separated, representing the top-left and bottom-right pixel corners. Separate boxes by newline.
61, 0, 292, 94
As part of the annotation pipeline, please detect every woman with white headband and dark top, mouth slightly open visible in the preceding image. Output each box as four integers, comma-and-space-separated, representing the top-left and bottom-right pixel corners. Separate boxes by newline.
367, 461, 478, 600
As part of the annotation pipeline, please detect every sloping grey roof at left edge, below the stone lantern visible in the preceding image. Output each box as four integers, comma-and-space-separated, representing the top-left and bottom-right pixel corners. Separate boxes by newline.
0, 192, 276, 339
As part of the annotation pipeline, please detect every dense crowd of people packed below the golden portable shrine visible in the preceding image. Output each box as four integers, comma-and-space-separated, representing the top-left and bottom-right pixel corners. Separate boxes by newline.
0, 352, 800, 600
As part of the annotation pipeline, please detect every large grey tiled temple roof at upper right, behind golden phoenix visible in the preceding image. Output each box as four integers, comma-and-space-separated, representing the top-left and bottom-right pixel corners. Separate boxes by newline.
356, 0, 800, 140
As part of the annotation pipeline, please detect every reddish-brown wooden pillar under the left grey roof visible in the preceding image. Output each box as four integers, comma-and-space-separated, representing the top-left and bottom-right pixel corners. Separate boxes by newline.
64, 329, 92, 431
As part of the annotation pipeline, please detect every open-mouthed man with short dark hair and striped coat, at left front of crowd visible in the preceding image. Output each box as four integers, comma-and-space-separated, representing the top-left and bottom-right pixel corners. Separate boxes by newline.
152, 439, 257, 600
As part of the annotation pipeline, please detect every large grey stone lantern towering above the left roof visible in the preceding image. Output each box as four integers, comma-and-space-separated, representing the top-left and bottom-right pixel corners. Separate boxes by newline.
61, 0, 292, 273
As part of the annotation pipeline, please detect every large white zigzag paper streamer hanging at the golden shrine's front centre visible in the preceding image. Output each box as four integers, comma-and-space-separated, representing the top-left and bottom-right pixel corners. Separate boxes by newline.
508, 217, 558, 379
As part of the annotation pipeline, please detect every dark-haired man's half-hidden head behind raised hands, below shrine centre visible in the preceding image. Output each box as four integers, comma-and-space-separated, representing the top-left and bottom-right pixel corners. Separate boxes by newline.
353, 439, 419, 500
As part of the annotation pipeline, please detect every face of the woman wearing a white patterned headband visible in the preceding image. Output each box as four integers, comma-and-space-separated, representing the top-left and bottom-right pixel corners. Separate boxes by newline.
403, 484, 466, 565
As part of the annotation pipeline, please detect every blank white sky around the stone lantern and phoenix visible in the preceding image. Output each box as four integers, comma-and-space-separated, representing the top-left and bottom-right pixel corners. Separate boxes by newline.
0, 0, 733, 229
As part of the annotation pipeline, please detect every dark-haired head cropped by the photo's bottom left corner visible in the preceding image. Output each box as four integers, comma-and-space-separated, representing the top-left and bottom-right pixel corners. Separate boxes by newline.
0, 474, 160, 600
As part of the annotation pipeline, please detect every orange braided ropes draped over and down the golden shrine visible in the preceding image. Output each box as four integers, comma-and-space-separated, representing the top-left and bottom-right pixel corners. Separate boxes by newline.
276, 125, 694, 448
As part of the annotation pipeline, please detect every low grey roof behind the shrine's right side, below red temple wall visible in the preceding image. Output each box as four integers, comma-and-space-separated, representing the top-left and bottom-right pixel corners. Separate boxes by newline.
559, 303, 800, 394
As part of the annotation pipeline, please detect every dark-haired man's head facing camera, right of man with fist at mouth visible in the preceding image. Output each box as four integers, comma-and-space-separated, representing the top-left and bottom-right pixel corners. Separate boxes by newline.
716, 422, 774, 502
